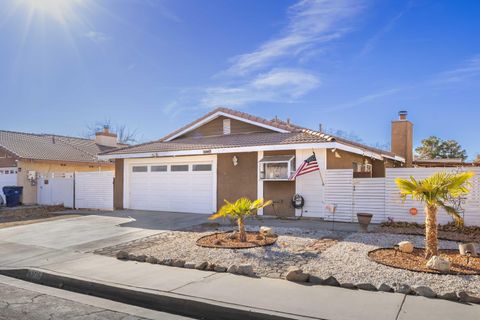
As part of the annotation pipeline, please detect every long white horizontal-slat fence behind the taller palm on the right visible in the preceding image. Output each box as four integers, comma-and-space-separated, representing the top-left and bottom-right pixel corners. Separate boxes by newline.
325, 168, 480, 225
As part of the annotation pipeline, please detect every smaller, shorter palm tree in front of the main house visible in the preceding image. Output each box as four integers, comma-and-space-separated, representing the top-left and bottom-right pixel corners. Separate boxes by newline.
209, 198, 272, 242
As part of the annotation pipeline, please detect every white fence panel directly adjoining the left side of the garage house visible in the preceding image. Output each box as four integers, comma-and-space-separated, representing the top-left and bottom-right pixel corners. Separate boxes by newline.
75, 171, 115, 210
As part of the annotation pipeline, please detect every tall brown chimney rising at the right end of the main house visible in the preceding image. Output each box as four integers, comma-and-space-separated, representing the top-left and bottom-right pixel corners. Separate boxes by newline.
392, 111, 413, 167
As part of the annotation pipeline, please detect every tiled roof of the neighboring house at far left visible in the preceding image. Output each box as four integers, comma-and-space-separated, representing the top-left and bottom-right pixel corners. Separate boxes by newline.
0, 130, 115, 163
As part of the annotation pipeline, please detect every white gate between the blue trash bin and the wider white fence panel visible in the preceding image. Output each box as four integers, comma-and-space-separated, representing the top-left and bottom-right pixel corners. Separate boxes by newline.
37, 173, 74, 208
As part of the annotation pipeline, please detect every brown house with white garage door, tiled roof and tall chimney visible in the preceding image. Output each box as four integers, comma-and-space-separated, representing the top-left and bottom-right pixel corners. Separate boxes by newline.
100, 108, 413, 216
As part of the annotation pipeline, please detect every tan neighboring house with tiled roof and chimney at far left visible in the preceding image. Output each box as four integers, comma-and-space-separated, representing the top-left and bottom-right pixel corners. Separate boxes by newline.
0, 129, 119, 204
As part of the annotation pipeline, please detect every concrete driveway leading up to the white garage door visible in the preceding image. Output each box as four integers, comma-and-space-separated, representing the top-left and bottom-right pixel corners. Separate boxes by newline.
0, 211, 208, 252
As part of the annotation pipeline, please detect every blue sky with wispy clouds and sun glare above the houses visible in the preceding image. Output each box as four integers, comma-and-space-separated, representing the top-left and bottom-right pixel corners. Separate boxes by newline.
0, 0, 480, 157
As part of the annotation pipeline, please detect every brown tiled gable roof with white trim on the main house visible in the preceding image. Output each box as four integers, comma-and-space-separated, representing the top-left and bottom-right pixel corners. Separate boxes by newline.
102, 107, 401, 160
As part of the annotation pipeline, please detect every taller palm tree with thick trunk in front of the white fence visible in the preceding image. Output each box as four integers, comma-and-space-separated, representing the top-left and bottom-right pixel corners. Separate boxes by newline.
395, 172, 474, 259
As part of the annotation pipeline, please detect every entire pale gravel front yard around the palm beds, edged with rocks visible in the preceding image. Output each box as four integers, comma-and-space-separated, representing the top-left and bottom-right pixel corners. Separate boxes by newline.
96, 228, 480, 295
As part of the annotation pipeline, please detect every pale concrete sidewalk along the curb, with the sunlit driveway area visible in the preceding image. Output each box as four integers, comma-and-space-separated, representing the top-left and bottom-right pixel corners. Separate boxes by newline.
0, 212, 480, 320
